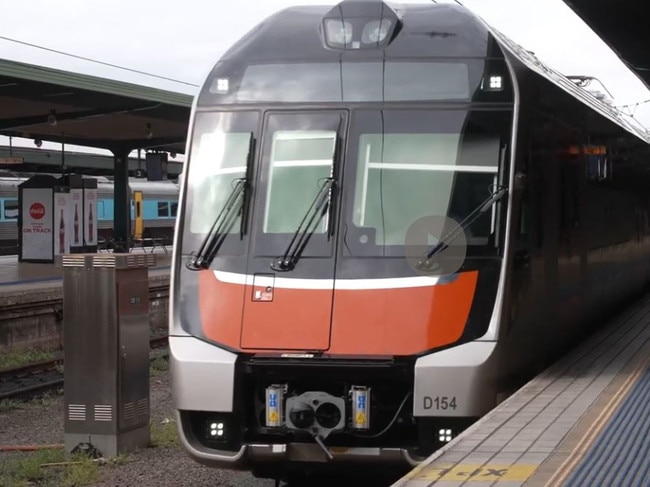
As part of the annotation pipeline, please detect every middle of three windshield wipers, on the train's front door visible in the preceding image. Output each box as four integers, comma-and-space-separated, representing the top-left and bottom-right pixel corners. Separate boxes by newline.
271, 177, 334, 272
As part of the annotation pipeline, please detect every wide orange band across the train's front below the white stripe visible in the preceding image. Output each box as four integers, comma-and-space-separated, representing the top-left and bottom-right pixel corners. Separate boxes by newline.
199, 271, 478, 355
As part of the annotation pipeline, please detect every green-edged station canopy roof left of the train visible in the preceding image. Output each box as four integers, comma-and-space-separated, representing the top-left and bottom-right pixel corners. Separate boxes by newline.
0, 59, 192, 153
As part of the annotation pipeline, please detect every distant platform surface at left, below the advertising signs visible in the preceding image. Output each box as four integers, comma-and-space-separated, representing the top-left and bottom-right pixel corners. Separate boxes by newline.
0, 247, 171, 296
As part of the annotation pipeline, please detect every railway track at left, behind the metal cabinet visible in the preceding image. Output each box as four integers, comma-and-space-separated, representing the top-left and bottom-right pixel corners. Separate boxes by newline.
0, 336, 168, 401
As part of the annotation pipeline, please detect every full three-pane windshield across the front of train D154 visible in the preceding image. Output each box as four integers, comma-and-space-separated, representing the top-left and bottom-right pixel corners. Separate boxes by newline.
183, 109, 512, 262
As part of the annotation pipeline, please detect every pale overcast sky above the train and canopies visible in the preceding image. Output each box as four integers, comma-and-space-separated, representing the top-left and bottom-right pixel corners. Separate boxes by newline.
0, 0, 650, 149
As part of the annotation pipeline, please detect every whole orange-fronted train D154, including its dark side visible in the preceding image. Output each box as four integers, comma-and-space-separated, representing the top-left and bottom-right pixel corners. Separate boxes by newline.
169, 0, 650, 485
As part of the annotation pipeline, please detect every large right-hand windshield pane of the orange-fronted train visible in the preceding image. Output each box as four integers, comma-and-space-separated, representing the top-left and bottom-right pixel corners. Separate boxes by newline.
345, 109, 511, 256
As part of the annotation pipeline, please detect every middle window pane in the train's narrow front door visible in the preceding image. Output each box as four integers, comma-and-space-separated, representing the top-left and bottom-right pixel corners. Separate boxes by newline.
264, 130, 336, 233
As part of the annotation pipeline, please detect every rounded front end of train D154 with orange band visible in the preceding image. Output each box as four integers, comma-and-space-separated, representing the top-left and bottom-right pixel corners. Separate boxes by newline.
169, 0, 514, 476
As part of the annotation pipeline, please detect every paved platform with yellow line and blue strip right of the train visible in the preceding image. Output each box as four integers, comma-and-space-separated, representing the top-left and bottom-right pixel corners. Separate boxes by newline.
393, 295, 650, 487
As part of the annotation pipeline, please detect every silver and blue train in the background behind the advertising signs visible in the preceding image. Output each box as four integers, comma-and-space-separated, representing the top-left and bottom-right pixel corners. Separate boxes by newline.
0, 173, 178, 255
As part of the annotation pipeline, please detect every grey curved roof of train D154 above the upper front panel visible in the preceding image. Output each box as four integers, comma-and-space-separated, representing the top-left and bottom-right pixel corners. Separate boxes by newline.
198, 0, 650, 143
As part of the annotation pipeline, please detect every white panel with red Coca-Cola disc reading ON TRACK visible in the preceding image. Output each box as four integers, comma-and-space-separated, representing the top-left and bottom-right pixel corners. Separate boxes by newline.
21, 188, 54, 261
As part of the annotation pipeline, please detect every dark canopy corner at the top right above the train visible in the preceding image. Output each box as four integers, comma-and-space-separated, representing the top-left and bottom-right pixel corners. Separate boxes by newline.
565, 0, 650, 87
